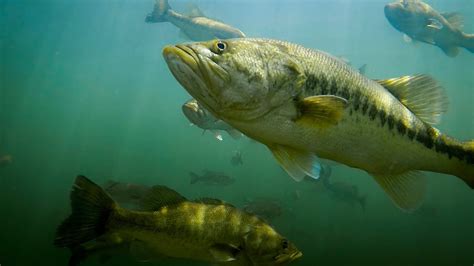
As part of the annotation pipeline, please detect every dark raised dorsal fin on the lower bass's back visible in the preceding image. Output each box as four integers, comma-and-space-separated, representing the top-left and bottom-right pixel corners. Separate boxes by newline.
139, 186, 187, 211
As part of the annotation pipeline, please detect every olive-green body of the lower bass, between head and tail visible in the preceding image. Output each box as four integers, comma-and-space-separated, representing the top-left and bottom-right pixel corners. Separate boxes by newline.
108, 202, 254, 262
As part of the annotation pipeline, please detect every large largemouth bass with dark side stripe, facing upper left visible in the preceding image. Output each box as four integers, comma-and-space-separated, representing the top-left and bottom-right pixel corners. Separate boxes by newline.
163, 39, 474, 210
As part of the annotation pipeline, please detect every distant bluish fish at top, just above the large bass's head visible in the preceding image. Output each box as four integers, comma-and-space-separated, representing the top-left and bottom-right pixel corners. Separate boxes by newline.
145, 0, 245, 41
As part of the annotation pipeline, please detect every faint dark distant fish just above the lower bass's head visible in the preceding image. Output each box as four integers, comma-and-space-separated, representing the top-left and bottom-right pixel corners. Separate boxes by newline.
244, 197, 283, 221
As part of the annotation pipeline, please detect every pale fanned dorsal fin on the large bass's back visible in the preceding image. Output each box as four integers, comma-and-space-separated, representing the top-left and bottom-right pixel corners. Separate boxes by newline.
377, 75, 448, 125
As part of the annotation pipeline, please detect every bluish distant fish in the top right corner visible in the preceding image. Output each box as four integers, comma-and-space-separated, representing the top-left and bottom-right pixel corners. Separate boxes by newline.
385, 0, 474, 57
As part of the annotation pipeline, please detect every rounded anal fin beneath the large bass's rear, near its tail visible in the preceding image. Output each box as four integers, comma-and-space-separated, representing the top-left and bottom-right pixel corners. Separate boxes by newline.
374, 171, 426, 212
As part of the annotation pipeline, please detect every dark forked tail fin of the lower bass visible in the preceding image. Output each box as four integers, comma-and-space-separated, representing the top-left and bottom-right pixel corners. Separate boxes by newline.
54, 176, 115, 249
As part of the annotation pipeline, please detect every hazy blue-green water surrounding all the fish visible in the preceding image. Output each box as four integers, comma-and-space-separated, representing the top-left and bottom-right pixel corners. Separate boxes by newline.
0, 0, 474, 266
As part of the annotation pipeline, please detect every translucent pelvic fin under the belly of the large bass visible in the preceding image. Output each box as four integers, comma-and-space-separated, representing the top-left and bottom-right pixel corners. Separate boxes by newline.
268, 145, 321, 182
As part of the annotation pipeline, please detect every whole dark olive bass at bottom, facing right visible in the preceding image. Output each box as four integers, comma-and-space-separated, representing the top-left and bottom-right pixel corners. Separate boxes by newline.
54, 176, 302, 265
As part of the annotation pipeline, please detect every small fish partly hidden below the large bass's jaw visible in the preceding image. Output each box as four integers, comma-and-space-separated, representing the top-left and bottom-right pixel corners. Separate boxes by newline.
182, 99, 242, 141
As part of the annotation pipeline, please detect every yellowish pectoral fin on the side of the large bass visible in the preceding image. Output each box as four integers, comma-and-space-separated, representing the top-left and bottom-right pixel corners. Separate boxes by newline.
299, 95, 348, 126
